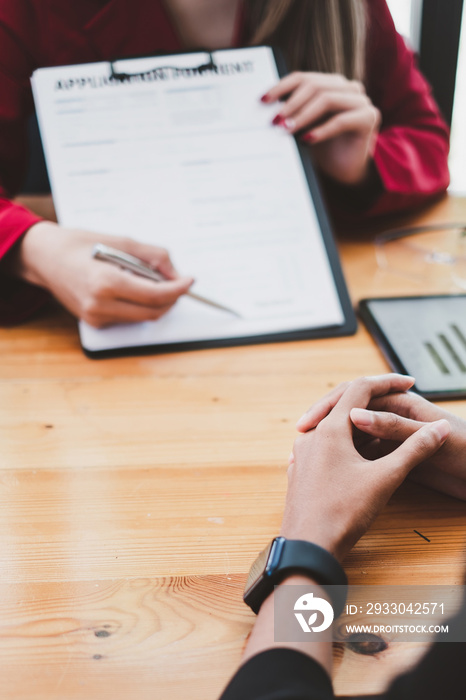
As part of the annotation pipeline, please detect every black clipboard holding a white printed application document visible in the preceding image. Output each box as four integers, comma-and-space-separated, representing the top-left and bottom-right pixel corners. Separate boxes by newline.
32, 46, 356, 358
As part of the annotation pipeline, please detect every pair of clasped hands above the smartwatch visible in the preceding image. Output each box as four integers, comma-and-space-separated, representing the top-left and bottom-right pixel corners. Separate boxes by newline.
281, 374, 456, 559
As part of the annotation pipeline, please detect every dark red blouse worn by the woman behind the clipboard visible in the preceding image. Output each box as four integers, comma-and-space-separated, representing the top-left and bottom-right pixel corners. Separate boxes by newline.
0, 0, 449, 325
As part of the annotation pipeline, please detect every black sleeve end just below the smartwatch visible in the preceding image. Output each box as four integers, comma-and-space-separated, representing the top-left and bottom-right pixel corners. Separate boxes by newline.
220, 649, 334, 700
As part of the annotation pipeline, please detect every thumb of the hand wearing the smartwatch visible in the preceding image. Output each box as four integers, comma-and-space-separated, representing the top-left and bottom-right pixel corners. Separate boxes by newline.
381, 419, 450, 480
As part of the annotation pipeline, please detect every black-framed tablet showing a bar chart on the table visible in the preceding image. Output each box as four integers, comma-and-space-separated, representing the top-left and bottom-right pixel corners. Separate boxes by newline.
359, 294, 466, 400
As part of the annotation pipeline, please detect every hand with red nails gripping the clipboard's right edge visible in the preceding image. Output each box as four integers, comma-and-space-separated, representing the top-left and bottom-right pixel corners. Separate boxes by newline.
262, 72, 381, 185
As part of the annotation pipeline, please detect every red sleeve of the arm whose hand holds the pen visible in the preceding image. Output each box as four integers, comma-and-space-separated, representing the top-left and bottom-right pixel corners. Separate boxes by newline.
0, 0, 46, 325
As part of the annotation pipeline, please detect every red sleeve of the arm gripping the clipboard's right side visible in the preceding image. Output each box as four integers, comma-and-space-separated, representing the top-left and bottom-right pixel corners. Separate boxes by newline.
366, 0, 449, 216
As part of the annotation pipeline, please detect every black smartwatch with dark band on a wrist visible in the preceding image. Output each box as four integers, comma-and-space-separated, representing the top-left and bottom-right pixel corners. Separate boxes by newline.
243, 537, 348, 617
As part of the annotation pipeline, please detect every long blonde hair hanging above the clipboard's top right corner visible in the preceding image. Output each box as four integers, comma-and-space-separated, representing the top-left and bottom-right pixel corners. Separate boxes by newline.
246, 0, 366, 80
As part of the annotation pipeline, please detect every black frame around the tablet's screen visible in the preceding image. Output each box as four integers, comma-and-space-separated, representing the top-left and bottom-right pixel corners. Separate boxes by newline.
357, 294, 466, 401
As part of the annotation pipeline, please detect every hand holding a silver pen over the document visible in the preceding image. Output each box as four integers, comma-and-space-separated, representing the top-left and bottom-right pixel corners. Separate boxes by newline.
9, 221, 193, 328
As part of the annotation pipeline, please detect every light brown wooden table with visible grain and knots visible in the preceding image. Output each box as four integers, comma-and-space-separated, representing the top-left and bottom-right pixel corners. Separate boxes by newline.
0, 194, 466, 700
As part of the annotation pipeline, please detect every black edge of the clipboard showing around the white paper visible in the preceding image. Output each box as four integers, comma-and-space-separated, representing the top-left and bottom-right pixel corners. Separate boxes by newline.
73, 44, 357, 360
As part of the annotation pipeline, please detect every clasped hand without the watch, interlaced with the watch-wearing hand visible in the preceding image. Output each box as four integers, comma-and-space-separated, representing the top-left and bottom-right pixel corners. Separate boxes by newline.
298, 377, 466, 500
